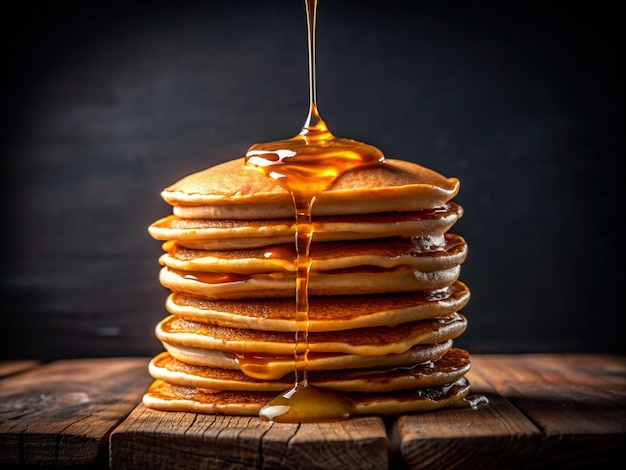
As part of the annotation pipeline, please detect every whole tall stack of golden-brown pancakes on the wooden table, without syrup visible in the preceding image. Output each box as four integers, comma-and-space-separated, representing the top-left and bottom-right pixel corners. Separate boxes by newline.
144, 159, 470, 415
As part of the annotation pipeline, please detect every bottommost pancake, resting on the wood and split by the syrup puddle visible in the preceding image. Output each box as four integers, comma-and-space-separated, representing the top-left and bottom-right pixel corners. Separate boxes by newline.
143, 377, 469, 416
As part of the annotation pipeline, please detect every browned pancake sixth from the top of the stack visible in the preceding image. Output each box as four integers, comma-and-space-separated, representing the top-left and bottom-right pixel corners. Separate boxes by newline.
156, 313, 467, 356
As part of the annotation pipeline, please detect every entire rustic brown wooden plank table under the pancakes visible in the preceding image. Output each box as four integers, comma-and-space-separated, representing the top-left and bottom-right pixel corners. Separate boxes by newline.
0, 355, 626, 470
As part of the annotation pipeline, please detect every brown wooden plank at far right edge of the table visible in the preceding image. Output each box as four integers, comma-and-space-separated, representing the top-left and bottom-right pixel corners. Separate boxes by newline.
476, 354, 626, 468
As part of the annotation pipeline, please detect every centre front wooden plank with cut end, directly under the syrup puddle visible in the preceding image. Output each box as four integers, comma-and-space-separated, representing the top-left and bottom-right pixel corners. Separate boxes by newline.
110, 405, 388, 470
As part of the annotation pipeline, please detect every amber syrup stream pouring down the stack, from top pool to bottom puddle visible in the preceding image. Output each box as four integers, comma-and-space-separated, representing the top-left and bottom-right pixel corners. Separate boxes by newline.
246, 0, 384, 423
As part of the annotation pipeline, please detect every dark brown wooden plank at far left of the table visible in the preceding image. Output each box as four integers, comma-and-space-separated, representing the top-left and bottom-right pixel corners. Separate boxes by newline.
0, 358, 151, 465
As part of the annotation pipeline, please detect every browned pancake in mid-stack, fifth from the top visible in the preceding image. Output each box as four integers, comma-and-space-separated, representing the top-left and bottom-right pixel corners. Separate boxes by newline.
165, 281, 470, 332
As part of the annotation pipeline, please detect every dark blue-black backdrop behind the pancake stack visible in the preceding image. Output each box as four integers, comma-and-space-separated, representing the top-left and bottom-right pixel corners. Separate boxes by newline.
0, 0, 625, 360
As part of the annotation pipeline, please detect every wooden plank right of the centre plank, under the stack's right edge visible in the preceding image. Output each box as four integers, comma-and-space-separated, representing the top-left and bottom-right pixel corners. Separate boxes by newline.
390, 365, 542, 469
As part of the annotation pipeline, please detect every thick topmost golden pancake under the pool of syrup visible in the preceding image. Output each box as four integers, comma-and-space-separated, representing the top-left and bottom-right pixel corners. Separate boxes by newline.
162, 158, 459, 220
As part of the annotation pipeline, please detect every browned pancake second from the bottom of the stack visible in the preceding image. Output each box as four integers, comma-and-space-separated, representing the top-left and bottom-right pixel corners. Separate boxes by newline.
149, 349, 470, 393
